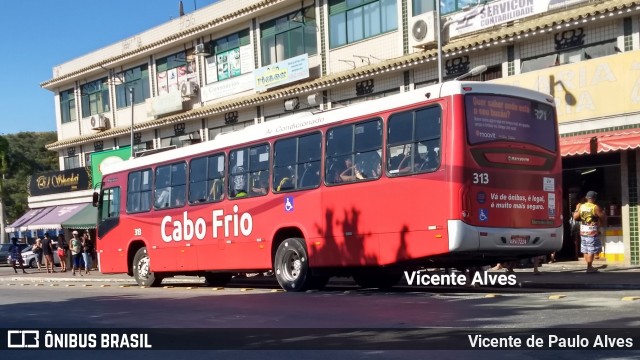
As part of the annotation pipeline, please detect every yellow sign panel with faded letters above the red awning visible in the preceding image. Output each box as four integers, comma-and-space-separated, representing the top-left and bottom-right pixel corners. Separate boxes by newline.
490, 51, 640, 123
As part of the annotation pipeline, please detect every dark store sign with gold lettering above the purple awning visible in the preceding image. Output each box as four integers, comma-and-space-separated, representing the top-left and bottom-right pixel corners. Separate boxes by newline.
29, 168, 91, 196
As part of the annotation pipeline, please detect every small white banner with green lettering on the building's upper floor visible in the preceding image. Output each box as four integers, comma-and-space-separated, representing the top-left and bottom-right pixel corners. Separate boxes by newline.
253, 54, 309, 92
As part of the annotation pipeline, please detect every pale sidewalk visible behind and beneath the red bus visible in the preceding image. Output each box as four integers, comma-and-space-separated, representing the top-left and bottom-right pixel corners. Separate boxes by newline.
0, 260, 640, 290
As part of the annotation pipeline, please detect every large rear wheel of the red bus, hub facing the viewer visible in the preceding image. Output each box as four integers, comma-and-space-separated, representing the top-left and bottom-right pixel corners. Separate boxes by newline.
273, 238, 312, 291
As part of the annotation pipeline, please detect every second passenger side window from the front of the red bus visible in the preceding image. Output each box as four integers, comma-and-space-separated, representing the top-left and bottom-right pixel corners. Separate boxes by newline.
155, 162, 187, 209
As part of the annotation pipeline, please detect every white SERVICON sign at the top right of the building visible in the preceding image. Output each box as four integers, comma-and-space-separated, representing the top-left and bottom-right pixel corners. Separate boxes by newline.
449, 0, 588, 38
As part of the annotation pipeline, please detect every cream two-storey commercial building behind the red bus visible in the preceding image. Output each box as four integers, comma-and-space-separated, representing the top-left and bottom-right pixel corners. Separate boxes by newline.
38, 0, 640, 265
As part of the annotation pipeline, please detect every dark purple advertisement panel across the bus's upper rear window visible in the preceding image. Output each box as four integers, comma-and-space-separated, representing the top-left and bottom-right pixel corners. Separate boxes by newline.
465, 94, 557, 153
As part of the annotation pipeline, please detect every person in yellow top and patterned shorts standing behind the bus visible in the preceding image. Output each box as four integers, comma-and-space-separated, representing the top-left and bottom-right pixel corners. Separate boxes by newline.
573, 191, 607, 273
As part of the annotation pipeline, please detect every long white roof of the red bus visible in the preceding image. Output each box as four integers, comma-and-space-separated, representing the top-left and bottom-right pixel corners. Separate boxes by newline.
102, 81, 554, 175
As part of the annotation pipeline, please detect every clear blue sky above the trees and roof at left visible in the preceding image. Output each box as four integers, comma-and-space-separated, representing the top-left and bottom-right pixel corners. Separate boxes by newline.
0, 0, 219, 135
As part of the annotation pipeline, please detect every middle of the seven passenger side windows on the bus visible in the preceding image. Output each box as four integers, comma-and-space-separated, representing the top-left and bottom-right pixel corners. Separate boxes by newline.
229, 144, 269, 199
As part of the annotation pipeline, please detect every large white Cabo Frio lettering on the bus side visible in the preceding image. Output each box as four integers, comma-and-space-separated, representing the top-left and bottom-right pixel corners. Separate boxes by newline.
160, 205, 253, 243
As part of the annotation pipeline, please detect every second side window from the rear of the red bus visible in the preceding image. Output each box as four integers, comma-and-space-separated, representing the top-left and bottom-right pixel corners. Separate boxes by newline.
324, 119, 382, 184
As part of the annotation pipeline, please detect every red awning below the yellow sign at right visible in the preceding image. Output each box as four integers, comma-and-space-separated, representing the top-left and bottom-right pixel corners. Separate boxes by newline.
560, 129, 640, 156
